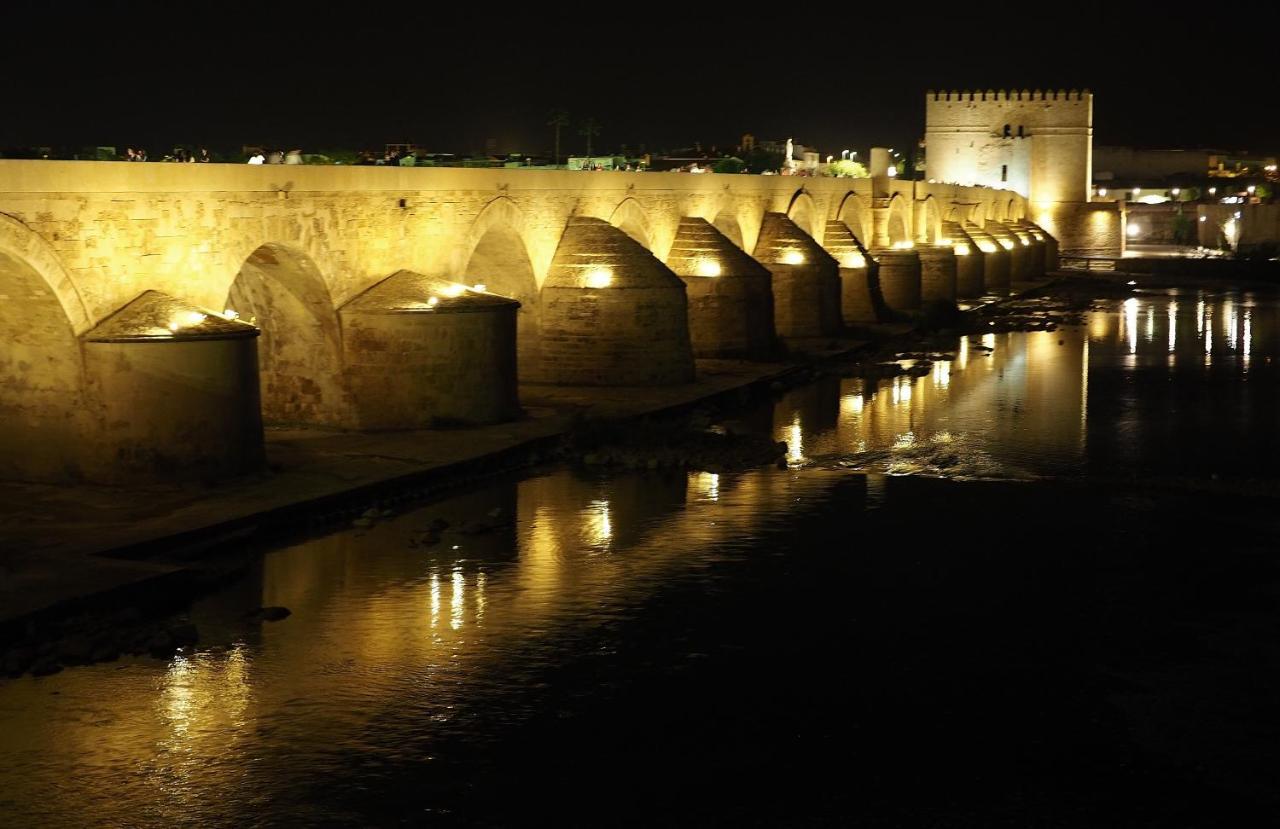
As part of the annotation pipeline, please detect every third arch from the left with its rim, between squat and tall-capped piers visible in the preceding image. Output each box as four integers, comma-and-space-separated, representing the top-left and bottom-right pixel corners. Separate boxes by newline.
458, 196, 541, 379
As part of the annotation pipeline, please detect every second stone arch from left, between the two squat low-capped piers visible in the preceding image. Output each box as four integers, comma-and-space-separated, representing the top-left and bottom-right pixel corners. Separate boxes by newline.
225, 242, 351, 426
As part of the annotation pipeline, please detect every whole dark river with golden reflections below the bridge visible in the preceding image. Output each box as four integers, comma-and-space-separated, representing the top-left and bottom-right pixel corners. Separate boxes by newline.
0, 290, 1280, 826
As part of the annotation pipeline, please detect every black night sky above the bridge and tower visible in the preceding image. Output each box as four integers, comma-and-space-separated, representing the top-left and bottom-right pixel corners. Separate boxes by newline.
0, 3, 1280, 152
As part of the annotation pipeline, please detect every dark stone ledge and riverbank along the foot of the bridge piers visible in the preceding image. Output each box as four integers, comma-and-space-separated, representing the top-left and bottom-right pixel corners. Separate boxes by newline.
0, 279, 1052, 643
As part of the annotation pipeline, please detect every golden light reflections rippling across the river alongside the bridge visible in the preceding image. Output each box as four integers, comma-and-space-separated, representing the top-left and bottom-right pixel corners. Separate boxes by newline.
0, 287, 1276, 825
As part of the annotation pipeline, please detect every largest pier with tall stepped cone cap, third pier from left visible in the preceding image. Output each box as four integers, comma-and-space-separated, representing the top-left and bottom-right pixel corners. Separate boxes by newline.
541, 216, 694, 385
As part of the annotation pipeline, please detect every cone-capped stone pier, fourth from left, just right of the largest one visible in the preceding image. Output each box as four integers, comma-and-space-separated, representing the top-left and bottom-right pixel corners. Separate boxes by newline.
667, 216, 777, 358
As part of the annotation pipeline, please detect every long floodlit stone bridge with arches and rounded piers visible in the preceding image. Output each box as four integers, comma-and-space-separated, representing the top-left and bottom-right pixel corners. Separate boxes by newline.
0, 161, 1055, 481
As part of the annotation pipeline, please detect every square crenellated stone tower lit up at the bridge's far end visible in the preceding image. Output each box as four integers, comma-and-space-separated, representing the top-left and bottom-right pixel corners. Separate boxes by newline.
924, 90, 1121, 255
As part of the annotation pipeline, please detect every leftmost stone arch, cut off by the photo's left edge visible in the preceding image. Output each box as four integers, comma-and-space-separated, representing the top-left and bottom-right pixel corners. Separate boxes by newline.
0, 216, 88, 481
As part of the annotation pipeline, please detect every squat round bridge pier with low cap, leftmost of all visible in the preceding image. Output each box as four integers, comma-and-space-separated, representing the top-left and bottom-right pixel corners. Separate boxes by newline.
82, 290, 265, 484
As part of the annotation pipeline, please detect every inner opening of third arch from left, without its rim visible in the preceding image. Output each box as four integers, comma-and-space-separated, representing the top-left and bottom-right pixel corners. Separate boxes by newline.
461, 221, 541, 381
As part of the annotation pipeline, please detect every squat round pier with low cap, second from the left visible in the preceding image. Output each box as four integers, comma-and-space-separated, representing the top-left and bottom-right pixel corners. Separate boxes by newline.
339, 271, 520, 430
